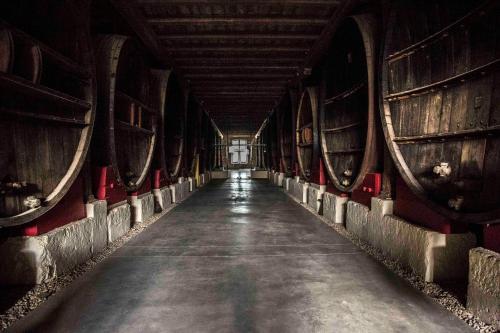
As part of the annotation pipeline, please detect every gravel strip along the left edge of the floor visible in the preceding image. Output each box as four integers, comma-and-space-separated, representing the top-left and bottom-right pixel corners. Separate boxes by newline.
0, 205, 176, 331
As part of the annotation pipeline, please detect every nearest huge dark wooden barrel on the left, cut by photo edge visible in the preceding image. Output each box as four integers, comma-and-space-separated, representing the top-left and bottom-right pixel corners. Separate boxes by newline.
0, 0, 96, 227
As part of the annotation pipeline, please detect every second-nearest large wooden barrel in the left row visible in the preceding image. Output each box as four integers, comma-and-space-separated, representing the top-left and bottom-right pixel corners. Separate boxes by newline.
92, 35, 158, 192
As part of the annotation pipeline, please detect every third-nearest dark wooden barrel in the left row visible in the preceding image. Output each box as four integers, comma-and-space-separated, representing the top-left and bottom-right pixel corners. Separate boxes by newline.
151, 70, 185, 182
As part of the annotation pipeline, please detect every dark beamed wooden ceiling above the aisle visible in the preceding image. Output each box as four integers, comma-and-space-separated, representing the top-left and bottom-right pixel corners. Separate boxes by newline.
113, 0, 348, 135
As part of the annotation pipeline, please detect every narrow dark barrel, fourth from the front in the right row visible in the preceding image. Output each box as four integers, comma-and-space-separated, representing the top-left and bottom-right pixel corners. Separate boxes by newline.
277, 91, 295, 173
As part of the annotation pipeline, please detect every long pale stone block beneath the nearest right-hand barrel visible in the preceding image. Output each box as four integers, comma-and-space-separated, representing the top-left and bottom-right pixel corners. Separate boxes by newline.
375, 215, 476, 282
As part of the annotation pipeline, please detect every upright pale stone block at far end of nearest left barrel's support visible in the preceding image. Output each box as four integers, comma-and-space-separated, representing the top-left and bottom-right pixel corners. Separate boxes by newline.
85, 200, 108, 253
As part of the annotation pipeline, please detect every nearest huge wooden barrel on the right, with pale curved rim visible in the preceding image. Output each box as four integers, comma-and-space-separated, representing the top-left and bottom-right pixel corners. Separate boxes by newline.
381, 1, 500, 222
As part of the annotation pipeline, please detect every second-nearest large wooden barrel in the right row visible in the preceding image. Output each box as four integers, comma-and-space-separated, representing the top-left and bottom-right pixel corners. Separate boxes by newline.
320, 15, 377, 192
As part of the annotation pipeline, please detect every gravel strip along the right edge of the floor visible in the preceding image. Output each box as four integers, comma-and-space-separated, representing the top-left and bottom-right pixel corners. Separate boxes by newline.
285, 192, 500, 333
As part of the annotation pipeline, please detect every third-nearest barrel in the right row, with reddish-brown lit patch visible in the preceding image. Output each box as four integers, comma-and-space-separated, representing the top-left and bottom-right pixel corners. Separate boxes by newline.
296, 87, 318, 181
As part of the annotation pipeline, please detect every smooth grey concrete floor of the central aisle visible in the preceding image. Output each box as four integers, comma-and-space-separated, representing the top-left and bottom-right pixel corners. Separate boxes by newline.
6, 171, 472, 333
